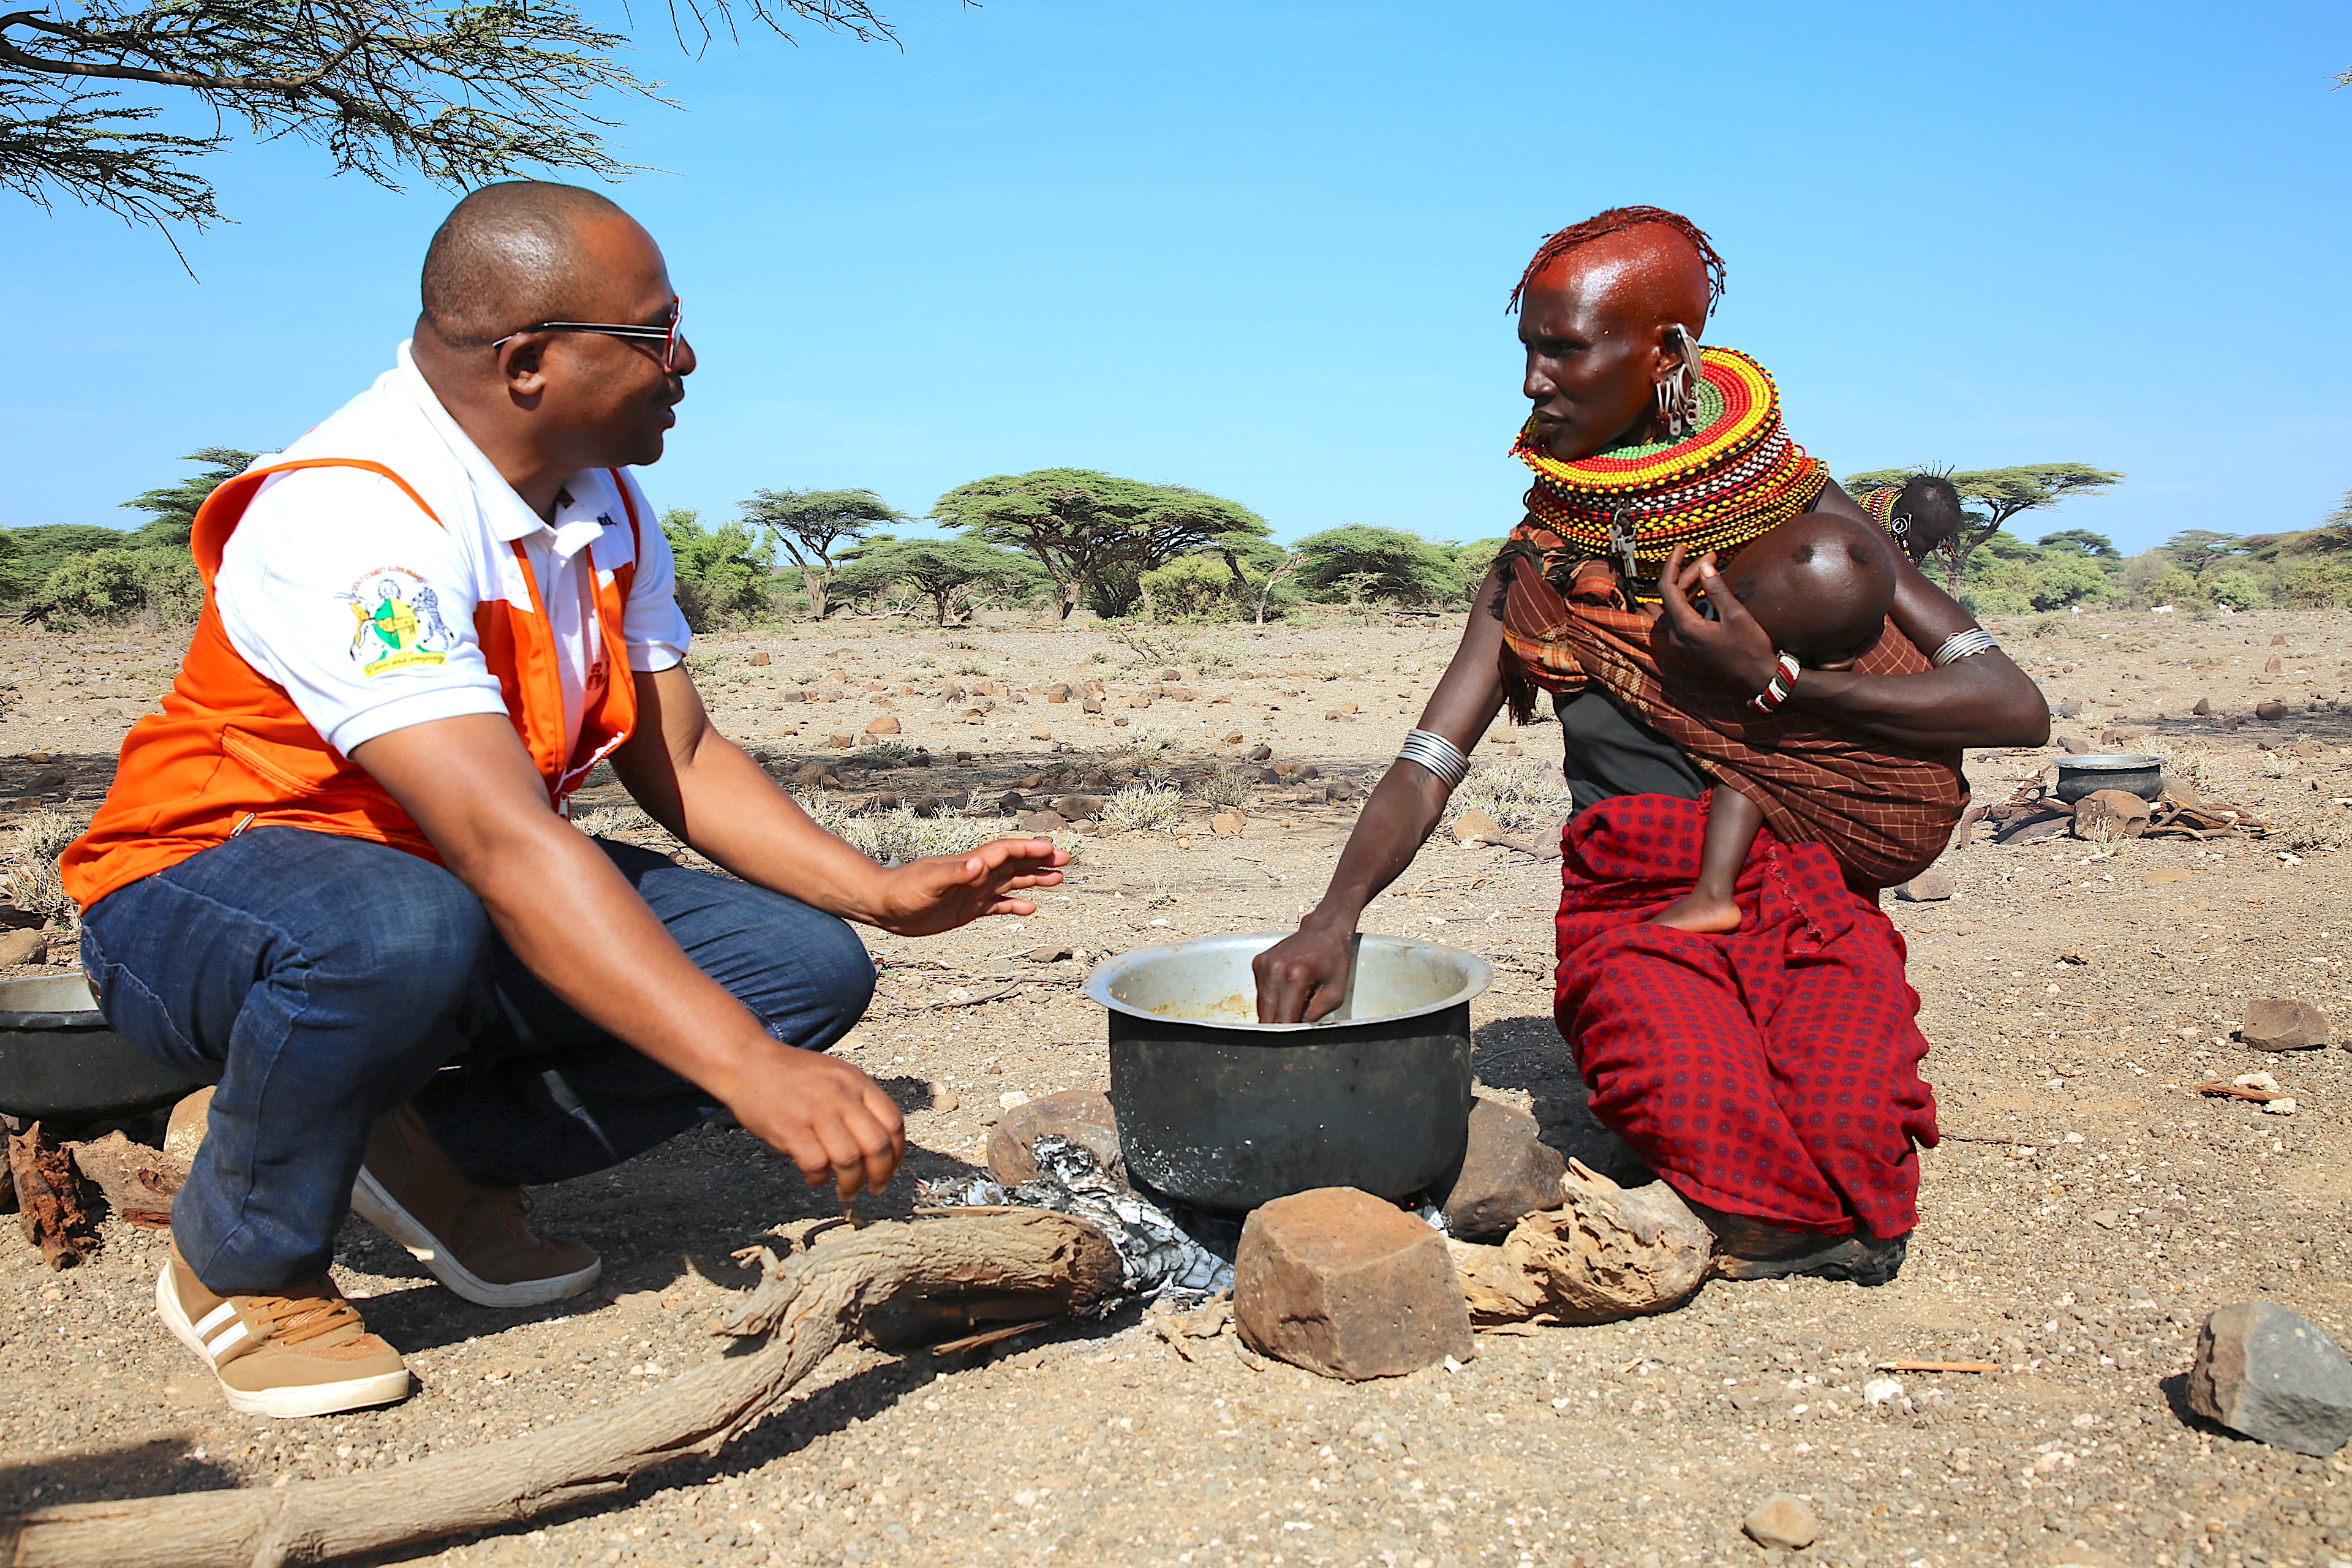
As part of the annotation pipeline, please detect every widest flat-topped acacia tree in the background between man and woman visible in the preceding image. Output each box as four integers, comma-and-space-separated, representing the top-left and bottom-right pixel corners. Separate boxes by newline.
932, 468, 1272, 620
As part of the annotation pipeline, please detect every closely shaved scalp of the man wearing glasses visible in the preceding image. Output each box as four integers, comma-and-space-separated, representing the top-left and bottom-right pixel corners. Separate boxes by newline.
419, 179, 635, 348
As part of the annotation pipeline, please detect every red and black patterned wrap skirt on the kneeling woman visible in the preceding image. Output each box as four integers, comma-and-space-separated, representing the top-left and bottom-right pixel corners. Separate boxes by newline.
1555, 794, 1936, 1237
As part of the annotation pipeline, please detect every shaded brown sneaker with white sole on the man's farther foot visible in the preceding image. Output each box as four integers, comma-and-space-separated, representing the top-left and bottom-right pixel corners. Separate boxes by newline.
350, 1105, 605, 1307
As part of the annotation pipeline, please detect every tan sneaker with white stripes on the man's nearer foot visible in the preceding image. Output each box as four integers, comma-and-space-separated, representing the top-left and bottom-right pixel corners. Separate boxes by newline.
155, 1246, 409, 1415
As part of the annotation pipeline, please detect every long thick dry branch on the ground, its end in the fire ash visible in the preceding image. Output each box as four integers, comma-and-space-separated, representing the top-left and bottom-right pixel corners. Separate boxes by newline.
0, 1208, 1122, 1568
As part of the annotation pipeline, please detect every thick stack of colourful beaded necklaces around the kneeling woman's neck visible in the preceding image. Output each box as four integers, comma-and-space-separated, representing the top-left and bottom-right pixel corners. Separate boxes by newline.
1510, 348, 1830, 567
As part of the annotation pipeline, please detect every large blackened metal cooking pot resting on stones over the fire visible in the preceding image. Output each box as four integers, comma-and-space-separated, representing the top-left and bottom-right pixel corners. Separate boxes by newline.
1087, 931, 1493, 1208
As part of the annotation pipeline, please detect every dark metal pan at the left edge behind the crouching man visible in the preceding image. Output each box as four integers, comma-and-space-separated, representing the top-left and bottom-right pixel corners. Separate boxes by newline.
0, 976, 200, 1121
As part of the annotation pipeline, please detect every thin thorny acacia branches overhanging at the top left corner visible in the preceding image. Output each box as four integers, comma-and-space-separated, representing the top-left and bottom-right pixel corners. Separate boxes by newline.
0, 0, 936, 228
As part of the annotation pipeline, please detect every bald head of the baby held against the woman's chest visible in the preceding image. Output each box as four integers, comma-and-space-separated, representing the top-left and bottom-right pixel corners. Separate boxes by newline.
1724, 513, 1896, 670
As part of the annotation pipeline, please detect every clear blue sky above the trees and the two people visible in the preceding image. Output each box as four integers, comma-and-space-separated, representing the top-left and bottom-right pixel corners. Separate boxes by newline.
0, 0, 2352, 548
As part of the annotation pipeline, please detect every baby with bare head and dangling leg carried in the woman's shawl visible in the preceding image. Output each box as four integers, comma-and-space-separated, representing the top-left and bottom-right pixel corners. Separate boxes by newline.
1649, 517, 1896, 931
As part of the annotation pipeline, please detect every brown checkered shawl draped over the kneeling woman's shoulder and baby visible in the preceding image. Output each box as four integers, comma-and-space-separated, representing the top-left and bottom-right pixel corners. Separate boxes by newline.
1498, 524, 1969, 889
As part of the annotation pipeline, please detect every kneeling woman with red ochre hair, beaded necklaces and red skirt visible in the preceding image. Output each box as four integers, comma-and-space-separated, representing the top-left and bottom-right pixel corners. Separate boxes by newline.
1258, 207, 2049, 1284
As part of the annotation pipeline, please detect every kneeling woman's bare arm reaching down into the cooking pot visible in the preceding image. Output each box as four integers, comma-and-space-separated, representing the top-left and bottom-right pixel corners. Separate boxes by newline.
1254, 567, 1506, 1023
